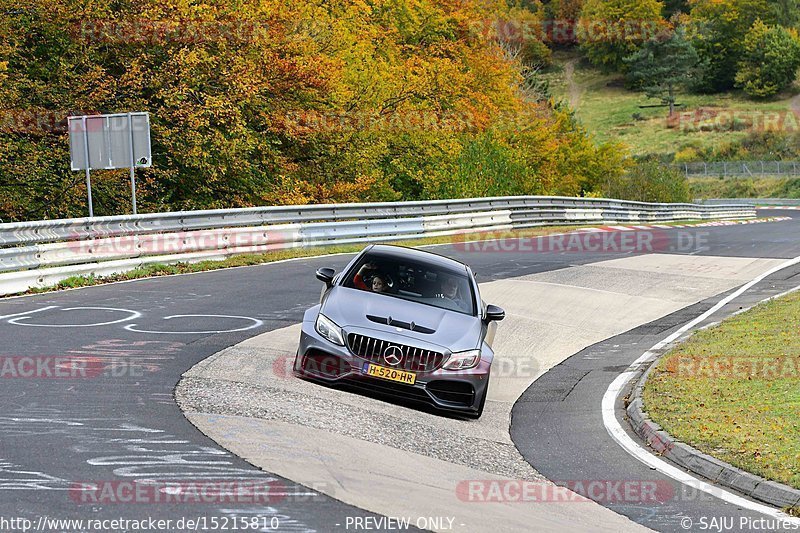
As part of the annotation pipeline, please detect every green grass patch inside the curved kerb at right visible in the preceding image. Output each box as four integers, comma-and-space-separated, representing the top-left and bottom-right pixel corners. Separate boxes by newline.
644, 292, 800, 492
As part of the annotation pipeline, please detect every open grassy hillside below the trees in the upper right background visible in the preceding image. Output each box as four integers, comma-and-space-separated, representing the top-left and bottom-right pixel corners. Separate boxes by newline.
544, 52, 800, 162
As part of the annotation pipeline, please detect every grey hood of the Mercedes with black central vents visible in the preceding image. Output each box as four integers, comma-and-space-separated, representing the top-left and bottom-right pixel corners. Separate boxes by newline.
320, 286, 482, 352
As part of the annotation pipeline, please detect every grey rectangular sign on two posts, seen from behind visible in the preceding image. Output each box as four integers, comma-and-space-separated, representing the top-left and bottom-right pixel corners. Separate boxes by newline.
67, 112, 152, 217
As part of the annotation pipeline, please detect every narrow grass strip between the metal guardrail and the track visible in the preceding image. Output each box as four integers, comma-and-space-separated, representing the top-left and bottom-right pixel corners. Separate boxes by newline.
17, 220, 732, 294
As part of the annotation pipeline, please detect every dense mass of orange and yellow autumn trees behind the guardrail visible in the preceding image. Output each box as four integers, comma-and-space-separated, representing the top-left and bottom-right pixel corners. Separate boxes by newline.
0, 0, 623, 220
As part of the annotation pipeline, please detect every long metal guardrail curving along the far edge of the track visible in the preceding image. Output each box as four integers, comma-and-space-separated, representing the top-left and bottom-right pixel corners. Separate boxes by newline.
0, 196, 755, 295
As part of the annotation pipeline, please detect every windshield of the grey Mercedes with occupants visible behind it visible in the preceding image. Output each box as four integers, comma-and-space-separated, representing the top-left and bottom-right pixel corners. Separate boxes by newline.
343, 254, 476, 316
